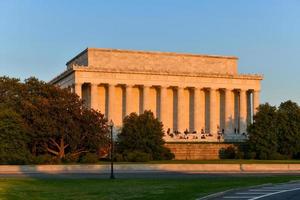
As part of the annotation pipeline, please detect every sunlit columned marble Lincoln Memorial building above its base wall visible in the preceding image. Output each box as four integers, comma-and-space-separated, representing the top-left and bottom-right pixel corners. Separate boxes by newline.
50, 48, 263, 142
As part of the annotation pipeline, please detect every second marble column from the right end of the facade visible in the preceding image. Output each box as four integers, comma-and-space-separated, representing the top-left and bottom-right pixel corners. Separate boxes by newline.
239, 90, 247, 133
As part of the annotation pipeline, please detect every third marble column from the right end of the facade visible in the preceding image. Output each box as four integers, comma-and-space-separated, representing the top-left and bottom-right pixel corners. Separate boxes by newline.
225, 88, 234, 134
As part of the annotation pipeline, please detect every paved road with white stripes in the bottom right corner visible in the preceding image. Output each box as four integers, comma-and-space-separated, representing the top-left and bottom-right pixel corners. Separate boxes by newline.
211, 182, 300, 200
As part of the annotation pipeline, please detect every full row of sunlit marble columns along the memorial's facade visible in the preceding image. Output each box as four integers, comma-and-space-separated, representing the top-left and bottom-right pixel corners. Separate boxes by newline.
74, 84, 259, 134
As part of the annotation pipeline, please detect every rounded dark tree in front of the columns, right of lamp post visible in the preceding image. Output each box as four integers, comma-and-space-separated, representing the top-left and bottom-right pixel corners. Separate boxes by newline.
118, 111, 174, 160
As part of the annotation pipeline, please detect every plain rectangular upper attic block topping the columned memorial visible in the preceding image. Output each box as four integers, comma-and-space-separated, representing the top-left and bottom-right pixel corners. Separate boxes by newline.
67, 48, 238, 75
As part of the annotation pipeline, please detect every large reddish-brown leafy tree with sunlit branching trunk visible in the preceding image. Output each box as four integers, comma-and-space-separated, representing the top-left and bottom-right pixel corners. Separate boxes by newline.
0, 77, 108, 162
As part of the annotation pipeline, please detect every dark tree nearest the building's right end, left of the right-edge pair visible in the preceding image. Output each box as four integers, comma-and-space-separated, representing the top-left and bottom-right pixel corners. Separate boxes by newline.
248, 103, 279, 159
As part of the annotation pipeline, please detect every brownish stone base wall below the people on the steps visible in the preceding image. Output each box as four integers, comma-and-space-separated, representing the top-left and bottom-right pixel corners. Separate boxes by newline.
165, 143, 236, 160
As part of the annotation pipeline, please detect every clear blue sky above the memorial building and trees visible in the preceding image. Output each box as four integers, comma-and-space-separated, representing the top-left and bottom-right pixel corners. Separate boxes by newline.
0, 0, 300, 104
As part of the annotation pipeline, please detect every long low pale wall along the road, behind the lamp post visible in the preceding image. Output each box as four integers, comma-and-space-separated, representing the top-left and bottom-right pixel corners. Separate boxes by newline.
0, 164, 300, 174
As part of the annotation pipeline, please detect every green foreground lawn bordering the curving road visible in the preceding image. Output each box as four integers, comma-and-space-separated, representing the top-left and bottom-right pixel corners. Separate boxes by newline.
0, 176, 300, 200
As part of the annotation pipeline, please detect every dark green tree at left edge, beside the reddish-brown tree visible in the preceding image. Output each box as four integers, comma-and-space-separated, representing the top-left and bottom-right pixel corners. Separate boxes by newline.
0, 107, 30, 164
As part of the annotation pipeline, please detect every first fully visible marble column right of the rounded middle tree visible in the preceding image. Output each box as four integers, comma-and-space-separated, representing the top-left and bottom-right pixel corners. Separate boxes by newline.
177, 87, 185, 133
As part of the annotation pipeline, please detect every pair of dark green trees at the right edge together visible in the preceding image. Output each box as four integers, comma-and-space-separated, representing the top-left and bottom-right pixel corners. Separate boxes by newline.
247, 101, 300, 159
